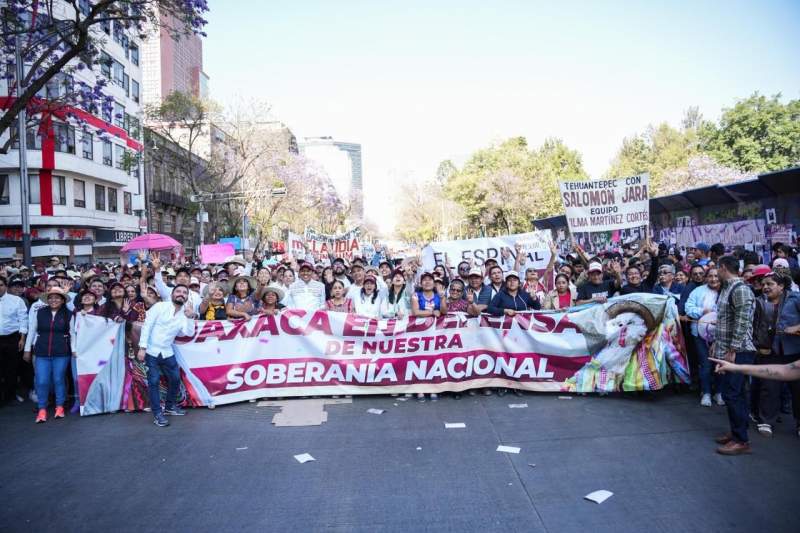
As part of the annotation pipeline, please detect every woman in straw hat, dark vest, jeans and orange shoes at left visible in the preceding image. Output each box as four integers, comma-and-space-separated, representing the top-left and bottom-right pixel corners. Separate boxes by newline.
23, 286, 74, 424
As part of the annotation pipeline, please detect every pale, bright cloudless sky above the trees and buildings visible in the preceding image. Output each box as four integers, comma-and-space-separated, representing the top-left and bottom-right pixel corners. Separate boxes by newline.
204, 0, 800, 233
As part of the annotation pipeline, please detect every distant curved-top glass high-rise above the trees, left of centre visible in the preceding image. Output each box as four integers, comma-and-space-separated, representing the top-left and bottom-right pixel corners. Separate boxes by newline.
300, 137, 364, 224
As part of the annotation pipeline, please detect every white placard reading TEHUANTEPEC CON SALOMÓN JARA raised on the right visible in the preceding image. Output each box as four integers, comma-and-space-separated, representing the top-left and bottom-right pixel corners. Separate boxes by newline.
559, 174, 650, 233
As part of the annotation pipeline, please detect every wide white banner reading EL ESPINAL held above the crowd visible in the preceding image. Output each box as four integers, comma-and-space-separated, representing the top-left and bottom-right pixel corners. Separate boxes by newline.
422, 231, 552, 270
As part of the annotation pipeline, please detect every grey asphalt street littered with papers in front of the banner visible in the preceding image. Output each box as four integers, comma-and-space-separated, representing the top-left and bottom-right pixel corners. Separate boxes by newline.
0, 386, 800, 533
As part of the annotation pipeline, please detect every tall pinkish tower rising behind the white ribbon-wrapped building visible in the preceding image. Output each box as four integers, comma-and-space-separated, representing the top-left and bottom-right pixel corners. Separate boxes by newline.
142, 10, 209, 105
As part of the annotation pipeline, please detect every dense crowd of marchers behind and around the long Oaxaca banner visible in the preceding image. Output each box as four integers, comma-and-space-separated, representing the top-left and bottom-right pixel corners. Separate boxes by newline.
0, 239, 800, 454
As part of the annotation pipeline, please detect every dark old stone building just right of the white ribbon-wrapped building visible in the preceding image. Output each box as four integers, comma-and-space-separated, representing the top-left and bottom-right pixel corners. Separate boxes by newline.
143, 128, 208, 256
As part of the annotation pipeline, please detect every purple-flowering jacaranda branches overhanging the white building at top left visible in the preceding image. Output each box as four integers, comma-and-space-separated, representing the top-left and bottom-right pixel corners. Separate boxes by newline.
0, 0, 208, 152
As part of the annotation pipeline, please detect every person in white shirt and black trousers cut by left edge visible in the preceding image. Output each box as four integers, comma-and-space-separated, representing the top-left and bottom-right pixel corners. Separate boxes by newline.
0, 276, 28, 404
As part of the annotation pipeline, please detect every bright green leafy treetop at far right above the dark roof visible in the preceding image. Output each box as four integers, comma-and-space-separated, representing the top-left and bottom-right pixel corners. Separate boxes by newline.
700, 92, 800, 172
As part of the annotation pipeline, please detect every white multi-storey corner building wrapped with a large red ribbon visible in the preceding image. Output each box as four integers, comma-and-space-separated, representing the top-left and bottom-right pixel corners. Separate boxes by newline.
0, 2, 144, 263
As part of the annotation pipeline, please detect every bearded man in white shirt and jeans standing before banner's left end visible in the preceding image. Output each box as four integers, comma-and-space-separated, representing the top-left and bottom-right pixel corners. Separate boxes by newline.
137, 285, 195, 427
